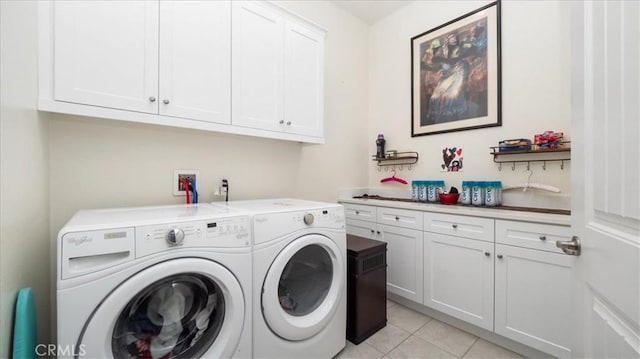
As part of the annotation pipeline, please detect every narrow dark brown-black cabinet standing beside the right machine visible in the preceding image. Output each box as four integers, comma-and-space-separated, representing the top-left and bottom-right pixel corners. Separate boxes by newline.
347, 234, 387, 344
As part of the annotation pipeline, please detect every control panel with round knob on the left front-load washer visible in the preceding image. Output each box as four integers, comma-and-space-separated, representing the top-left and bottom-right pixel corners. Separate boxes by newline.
135, 216, 251, 258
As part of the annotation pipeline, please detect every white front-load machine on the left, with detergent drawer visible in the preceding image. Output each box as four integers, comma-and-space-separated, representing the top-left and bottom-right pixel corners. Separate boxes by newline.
57, 205, 252, 358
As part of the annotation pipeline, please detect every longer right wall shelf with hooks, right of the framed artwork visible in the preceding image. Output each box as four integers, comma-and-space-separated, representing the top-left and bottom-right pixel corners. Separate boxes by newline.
489, 141, 571, 171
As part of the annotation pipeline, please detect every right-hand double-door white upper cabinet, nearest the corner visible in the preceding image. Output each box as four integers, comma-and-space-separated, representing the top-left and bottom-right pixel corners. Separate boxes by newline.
232, 2, 325, 138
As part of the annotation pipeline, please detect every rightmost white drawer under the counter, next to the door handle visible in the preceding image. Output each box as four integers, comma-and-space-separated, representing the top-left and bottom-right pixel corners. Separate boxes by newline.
496, 220, 571, 254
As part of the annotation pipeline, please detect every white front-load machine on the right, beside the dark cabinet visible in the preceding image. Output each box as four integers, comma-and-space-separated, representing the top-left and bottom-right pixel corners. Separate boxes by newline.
220, 199, 346, 359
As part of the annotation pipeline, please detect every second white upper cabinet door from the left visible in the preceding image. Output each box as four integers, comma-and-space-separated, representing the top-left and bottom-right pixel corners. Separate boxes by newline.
159, 1, 231, 123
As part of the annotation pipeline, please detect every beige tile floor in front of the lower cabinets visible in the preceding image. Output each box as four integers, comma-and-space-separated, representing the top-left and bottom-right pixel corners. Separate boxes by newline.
334, 301, 523, 359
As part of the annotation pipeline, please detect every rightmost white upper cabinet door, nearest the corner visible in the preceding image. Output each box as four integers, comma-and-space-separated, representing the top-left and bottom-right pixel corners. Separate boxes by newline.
284, 21, 324, 137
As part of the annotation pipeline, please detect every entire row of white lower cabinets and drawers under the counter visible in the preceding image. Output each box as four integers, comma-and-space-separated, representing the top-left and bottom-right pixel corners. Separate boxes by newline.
345, 204, 576, 357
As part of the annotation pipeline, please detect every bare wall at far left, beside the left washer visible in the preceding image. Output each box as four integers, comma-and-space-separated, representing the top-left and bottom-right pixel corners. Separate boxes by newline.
0, 1, 50, 358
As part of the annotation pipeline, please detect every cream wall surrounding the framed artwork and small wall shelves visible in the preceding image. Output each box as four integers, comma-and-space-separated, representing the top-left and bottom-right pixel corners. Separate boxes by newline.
368, 0, 571, 208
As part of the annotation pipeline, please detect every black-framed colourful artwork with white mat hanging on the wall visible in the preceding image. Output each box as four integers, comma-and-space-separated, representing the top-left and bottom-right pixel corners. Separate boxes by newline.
411, 1, 502, 137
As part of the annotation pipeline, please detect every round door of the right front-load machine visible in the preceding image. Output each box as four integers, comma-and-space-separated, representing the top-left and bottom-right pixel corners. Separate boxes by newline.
262, 234, 345, 340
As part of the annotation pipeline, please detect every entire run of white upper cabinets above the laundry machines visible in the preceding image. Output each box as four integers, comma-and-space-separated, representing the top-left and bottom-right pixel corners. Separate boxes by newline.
38, 0, 325, 143
